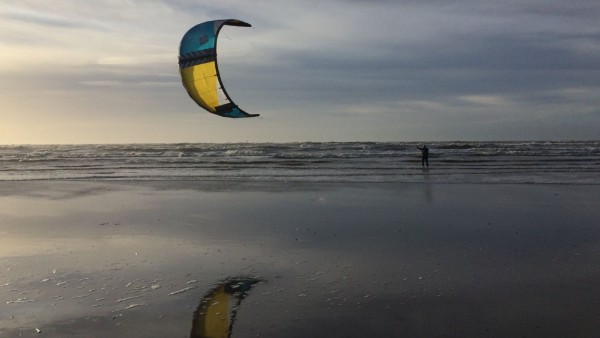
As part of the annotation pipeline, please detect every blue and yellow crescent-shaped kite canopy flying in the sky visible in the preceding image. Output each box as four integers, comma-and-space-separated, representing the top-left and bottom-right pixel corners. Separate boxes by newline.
179, 19, 258, 118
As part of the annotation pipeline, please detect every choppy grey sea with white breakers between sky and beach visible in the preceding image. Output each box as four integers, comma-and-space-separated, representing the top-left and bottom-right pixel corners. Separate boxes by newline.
0, 141, 600, 185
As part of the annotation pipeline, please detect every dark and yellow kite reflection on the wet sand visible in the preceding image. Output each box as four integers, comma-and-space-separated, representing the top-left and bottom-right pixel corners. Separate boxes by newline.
190, 277, 262, 338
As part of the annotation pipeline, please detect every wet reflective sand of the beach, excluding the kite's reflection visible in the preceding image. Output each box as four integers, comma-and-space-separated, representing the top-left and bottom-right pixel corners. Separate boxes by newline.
0, 181, 600, 338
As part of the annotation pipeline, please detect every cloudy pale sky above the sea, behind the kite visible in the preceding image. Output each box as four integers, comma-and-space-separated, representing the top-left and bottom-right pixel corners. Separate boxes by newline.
0, 0, 600, 144
